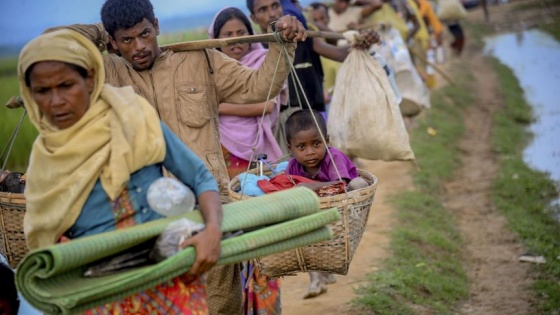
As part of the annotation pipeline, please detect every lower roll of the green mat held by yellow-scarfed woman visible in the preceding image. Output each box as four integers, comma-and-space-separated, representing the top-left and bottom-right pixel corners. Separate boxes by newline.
22, 209, 340, 308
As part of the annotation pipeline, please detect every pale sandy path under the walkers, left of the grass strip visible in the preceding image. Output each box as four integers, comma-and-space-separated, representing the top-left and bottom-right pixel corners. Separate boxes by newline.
282, 161, 412, 315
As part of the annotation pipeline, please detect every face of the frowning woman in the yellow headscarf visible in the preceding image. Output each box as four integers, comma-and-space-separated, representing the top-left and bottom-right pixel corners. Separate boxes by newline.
29, 61, 94, 129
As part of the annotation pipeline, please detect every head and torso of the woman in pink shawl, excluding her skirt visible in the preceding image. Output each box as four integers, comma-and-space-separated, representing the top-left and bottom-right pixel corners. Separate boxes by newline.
208, 7, 284, 177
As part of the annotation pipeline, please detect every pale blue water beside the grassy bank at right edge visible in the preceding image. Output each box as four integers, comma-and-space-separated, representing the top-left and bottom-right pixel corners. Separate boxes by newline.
485, 30, 560, 198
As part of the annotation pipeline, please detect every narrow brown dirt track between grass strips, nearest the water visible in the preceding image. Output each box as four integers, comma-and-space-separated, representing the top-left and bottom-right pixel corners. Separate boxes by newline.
445, 33, 532, 314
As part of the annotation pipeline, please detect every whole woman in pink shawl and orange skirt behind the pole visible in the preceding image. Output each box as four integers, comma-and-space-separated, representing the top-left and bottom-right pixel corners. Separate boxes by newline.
208, 7, 286, 314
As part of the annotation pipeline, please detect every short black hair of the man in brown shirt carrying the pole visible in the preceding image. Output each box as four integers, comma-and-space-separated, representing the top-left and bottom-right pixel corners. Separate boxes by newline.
101, 0, 156, 37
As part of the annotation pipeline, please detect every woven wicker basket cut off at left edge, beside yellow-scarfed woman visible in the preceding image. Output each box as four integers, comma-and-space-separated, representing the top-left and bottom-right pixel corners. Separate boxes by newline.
0, 192, 27, 268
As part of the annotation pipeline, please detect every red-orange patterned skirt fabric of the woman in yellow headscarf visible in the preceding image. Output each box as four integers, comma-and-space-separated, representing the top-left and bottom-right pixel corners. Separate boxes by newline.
84, 189, 212, 315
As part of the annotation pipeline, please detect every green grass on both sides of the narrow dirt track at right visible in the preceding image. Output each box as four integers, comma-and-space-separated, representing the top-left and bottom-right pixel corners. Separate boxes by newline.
353, 16, 560, 314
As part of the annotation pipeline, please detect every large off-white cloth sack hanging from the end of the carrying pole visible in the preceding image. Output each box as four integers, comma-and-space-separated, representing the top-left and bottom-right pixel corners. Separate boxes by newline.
327, 32, 414, 161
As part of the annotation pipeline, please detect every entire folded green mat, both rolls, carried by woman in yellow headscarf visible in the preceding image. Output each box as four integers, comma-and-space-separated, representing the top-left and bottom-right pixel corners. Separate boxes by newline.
16, 187, 334, 314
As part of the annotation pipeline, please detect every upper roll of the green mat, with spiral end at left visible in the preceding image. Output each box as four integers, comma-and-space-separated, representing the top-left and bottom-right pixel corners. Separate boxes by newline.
16, 187, 320, 278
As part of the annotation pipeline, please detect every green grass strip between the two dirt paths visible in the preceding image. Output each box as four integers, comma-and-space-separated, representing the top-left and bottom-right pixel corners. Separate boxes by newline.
353, 69, 473, 314
